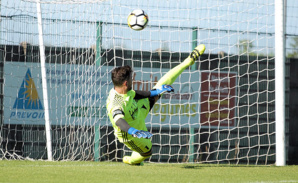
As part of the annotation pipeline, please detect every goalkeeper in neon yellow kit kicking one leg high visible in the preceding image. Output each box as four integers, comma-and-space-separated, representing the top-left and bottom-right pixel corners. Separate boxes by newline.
107, 44, 205, 165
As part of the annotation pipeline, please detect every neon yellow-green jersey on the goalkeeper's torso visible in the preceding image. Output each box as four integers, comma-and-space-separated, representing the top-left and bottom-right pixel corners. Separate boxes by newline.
107, 89, 150, 142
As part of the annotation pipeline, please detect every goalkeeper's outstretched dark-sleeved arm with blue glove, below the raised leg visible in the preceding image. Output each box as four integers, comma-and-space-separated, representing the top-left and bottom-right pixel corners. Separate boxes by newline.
135, 85, 174, 99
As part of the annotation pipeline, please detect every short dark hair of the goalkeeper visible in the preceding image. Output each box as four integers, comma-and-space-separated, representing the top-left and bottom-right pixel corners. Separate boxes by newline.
112, 65, 133, 86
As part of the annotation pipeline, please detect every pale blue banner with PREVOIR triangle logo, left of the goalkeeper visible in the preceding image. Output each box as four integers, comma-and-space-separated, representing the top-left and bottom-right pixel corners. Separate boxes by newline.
4, 62, 112, 125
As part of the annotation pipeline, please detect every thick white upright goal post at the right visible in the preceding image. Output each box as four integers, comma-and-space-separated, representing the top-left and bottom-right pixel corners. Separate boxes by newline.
275, 0, 286, 166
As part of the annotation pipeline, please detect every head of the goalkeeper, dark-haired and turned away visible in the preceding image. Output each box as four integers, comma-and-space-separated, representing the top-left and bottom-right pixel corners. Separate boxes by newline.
112, 65, 133, 91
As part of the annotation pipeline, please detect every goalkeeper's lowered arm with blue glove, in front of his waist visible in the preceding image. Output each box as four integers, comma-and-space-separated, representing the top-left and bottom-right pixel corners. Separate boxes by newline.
116, 118, 152, 139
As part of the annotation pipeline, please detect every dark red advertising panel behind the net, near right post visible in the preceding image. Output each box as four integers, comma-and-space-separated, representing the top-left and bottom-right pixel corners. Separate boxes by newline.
200, 72, 237, 127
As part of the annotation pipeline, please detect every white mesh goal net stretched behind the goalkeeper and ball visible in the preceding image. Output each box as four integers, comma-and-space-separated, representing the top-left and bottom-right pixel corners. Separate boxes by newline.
0, 0, 276, 164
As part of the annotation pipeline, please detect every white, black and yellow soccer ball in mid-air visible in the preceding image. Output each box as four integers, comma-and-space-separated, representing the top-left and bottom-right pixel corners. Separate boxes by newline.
127, 9, 149, 31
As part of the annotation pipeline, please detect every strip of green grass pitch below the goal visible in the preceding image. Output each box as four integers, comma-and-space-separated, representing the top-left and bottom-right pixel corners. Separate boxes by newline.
0, 160, 298, 183
